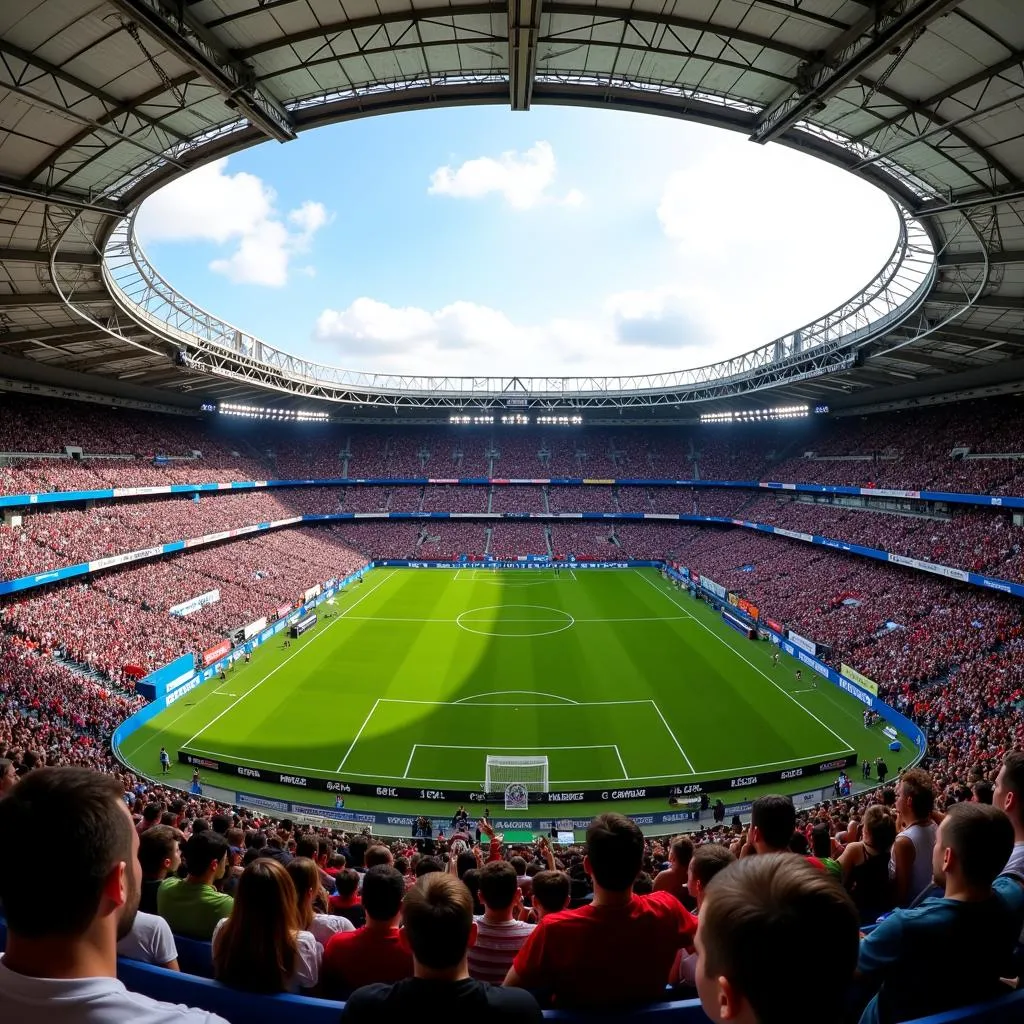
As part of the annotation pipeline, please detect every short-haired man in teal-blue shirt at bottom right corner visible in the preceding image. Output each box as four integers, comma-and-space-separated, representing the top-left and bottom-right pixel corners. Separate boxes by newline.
856, 803, 1024, 1024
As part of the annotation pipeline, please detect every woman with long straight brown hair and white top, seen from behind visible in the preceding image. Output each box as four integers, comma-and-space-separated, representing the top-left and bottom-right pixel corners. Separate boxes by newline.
213, 857, 324, 992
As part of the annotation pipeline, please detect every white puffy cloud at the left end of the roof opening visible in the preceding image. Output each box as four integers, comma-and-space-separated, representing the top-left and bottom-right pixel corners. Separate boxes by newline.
137, 158, 331, 288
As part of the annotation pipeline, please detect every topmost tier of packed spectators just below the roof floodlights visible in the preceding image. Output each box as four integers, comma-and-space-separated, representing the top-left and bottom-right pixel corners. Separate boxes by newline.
6, 395, 1024, 495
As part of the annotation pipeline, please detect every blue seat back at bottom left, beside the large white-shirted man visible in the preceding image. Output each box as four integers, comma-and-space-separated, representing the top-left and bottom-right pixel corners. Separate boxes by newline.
118, 958, 342, 1024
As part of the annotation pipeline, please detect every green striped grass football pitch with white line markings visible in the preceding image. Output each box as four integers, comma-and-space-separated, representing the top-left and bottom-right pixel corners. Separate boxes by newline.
120, 568, 905, 812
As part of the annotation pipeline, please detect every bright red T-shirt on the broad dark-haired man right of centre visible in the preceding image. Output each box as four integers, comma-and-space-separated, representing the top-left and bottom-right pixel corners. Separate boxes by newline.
512, 892, 697, 1007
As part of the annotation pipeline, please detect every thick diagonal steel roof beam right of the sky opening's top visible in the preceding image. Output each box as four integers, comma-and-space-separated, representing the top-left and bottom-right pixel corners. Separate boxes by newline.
751, 0, 961, 143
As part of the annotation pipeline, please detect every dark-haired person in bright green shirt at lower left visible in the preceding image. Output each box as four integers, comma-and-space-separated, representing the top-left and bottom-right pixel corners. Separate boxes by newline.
157, 829, 234, 942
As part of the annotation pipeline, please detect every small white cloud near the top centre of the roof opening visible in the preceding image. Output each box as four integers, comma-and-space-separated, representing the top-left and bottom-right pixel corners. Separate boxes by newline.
427, 141, 584, 210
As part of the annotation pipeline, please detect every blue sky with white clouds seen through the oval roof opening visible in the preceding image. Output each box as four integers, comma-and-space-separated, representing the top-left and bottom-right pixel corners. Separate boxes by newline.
139, 108, 897, 375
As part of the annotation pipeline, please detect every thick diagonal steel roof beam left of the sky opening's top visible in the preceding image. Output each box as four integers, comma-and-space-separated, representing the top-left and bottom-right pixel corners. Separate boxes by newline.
110, 0, 296, 142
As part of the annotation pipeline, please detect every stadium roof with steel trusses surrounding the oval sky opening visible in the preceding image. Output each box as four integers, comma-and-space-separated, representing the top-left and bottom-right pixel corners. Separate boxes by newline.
0, 0, 1024, 412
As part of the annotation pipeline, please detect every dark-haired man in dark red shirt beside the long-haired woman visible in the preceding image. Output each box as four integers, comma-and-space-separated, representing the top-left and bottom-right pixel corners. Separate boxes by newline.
321, 864, 413, 999
